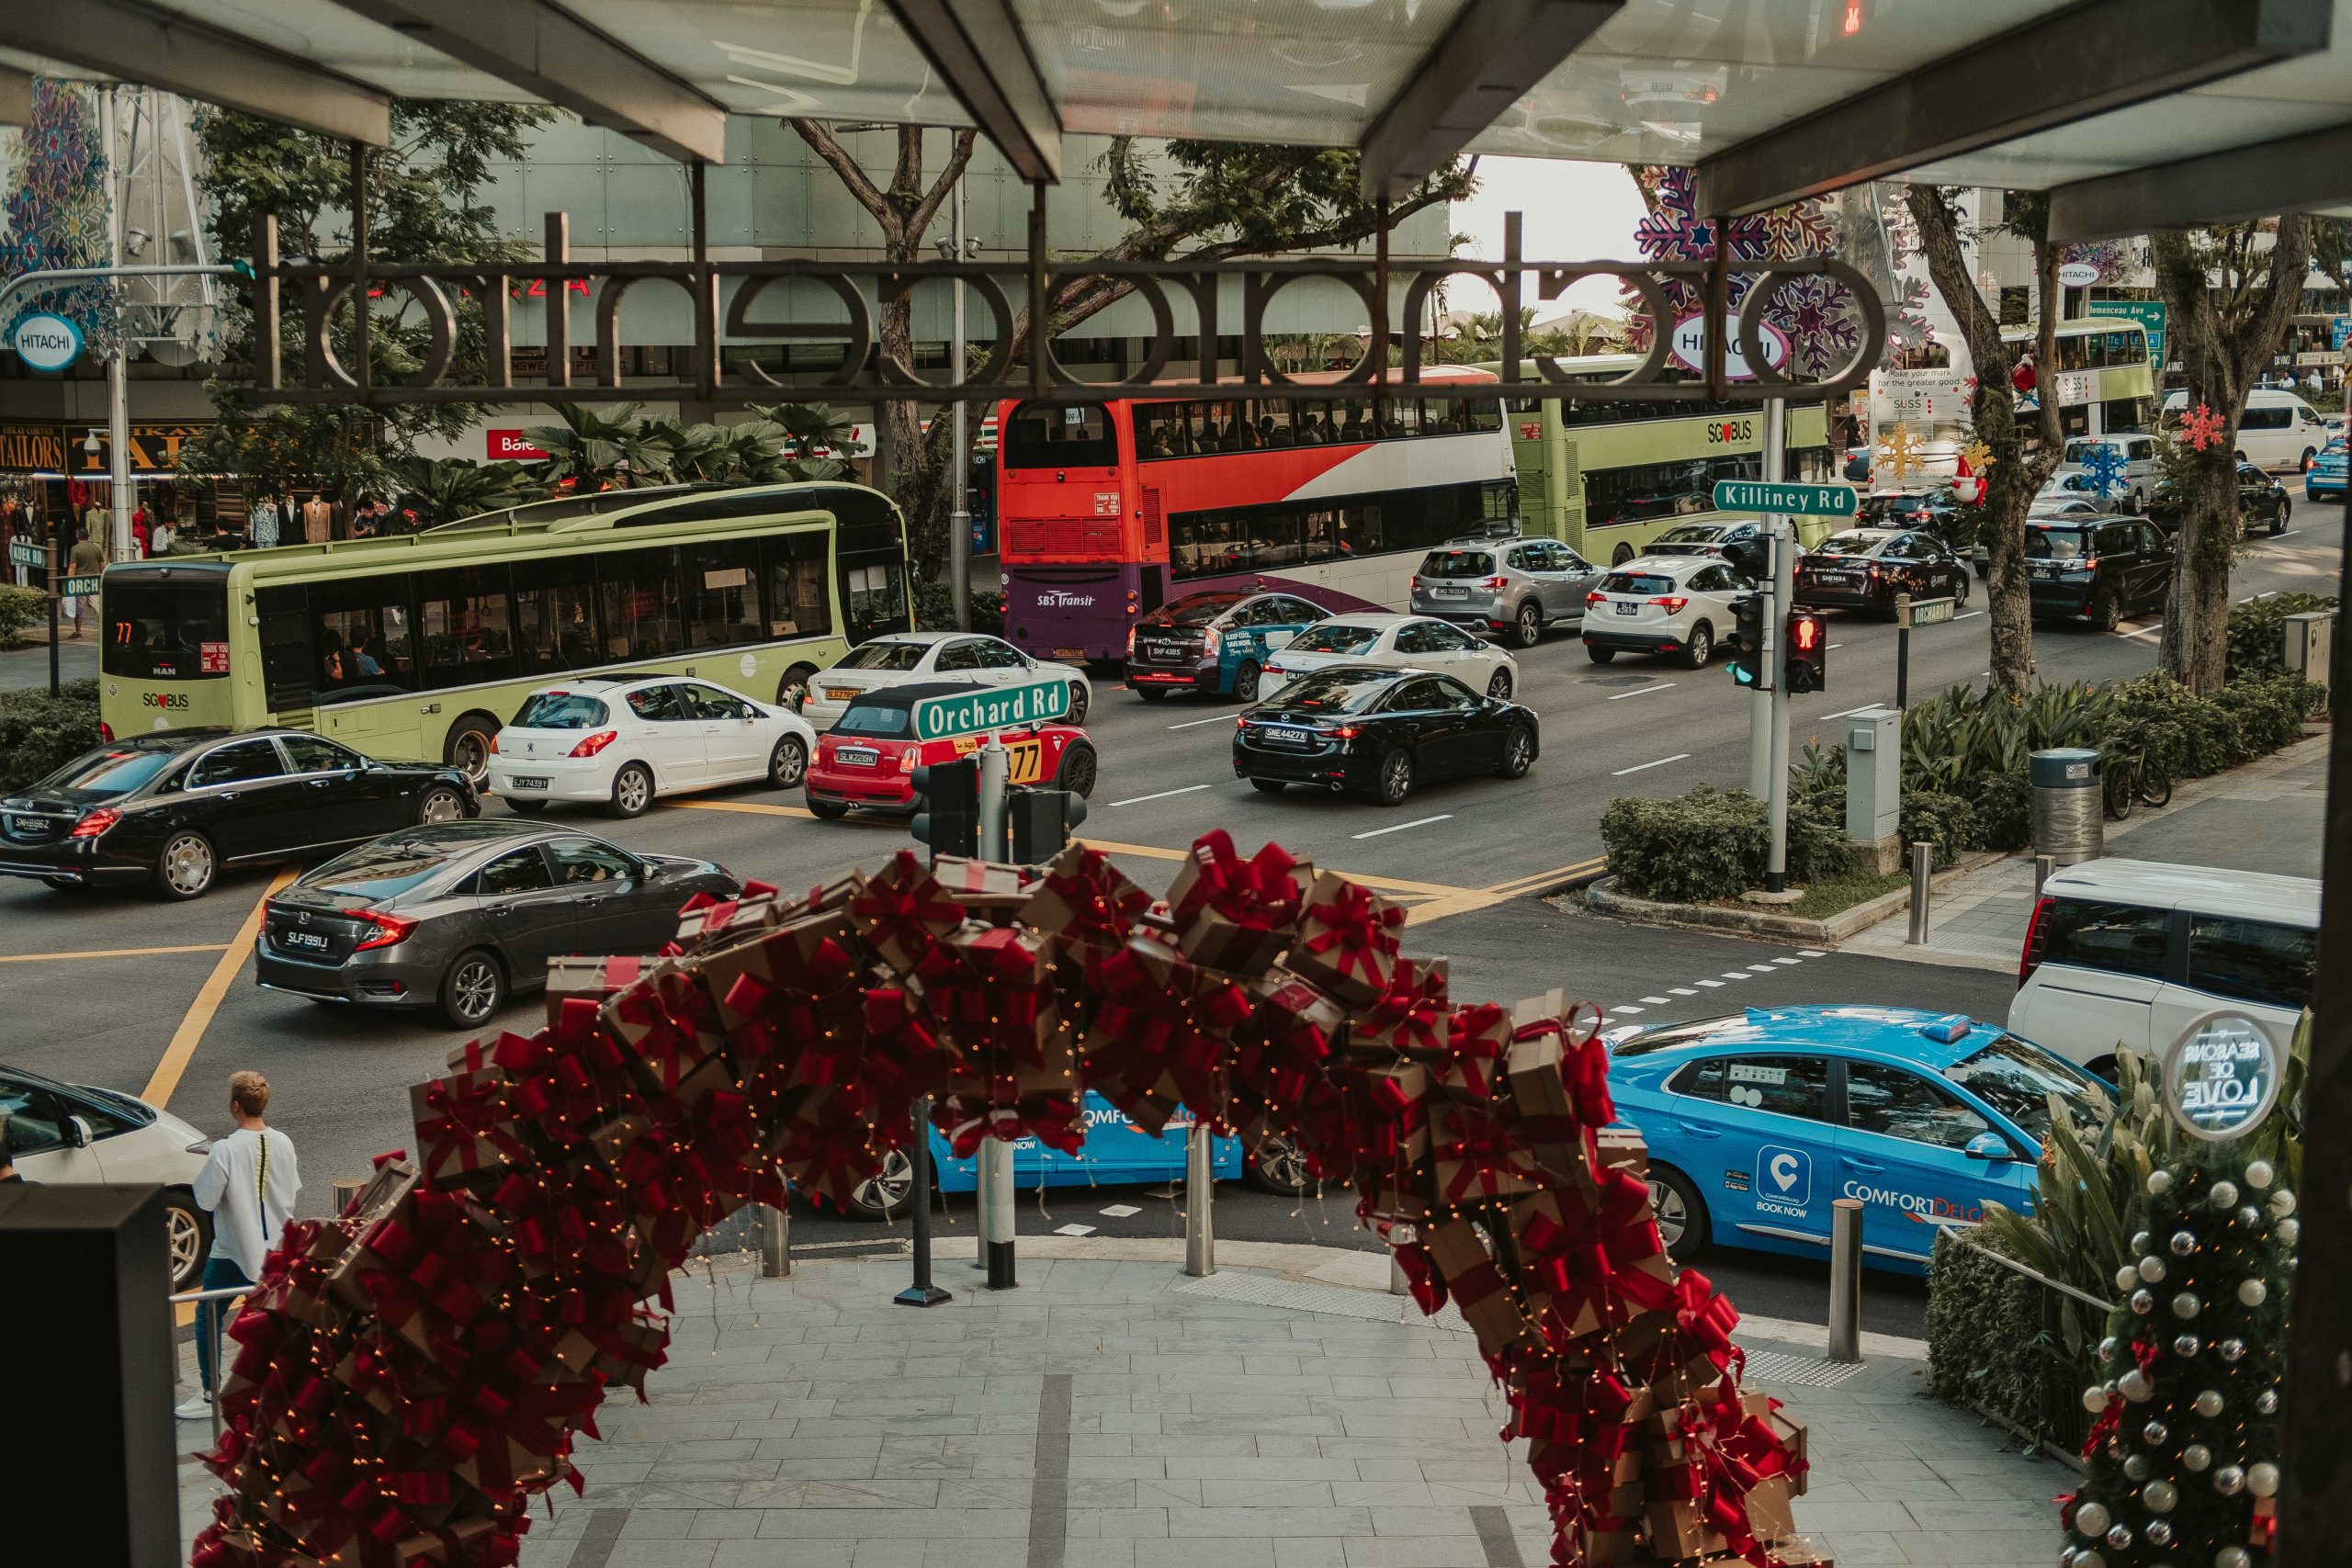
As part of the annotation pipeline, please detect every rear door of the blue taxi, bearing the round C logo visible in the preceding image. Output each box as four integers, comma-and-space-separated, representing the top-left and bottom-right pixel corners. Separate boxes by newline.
1642, 1051, 1837, 1258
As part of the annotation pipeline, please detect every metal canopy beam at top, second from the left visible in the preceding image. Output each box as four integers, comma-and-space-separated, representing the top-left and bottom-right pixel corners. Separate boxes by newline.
322, 0, 727, 163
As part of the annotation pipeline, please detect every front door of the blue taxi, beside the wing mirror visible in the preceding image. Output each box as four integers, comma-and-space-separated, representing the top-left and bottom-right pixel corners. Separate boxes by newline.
1830, 1060, 2032, 1269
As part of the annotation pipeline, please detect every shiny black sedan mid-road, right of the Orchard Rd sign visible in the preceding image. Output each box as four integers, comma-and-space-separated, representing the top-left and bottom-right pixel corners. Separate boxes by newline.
1232, 665, 1538, 807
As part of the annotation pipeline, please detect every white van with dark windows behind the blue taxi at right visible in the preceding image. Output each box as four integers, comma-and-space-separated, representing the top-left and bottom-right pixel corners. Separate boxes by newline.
2008, 861, 2319, 1075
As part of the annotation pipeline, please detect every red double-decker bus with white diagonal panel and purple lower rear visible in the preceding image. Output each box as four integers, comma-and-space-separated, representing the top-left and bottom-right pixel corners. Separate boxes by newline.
997, 365, 1517, 659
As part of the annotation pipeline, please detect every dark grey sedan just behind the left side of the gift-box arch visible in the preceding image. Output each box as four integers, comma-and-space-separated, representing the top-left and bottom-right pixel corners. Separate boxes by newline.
254, 820, 743, 1030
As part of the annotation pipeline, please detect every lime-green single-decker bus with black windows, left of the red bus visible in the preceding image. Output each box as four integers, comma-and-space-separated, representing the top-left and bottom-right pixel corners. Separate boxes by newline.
99, 482, 912, 778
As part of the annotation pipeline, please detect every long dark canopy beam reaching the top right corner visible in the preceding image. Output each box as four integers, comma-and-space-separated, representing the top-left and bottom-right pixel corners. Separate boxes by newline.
1698, 0, 2334, 216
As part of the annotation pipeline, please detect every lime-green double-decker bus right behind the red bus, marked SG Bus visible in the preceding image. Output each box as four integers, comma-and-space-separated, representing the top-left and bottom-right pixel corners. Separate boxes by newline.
1484, 355, 1837, 564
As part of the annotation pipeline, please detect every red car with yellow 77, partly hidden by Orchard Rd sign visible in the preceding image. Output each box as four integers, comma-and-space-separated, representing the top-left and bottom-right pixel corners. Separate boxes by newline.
809, 682, 1096, 820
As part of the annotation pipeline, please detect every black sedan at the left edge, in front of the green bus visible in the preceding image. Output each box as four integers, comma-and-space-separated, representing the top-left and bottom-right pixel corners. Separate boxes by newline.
0, 728, 482, 898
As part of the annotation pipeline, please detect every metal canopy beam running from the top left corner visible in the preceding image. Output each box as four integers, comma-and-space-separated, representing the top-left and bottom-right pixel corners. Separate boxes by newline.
0, 0, 393, 148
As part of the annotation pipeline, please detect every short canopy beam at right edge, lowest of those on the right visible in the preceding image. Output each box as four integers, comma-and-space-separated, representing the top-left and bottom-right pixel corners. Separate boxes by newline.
2051, 122, 2352, 244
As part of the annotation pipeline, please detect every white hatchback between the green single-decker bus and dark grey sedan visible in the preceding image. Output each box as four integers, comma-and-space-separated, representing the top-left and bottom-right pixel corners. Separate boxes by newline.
489, 674, 816, 816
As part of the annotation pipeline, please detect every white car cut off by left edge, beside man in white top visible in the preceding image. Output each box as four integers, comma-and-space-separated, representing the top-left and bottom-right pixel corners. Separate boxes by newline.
0, 1067, 211, 1291
